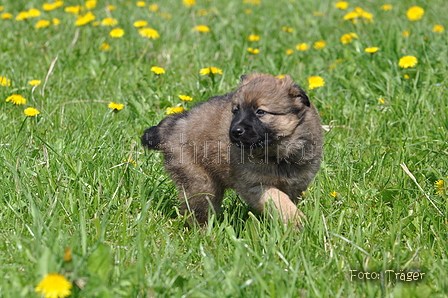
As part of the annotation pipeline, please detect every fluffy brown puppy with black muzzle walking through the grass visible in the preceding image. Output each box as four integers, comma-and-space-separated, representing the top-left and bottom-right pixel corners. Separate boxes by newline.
142, 74, 323, 226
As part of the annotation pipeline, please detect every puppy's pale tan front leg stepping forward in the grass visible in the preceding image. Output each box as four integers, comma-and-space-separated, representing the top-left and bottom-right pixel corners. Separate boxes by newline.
243, 186, 306, 228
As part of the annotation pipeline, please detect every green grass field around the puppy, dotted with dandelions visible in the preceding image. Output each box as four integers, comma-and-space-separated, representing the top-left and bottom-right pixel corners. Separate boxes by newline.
0, 0, 448, 297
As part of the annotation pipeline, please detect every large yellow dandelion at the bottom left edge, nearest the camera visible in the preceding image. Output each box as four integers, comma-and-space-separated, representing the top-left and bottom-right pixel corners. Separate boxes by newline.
34, 273, 72, 298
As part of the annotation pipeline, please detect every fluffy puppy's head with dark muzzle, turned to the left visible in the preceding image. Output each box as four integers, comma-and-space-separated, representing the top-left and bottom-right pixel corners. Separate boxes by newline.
229, 74, 310, 148
